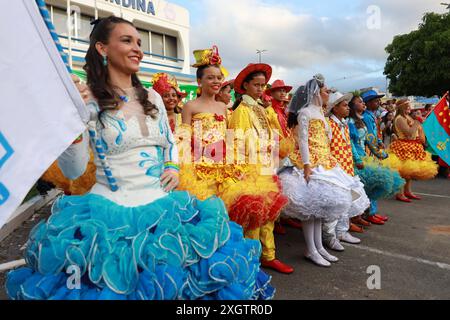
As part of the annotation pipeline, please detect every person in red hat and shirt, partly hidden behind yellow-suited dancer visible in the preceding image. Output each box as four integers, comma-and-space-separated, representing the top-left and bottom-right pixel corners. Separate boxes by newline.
265, 80, 302, 234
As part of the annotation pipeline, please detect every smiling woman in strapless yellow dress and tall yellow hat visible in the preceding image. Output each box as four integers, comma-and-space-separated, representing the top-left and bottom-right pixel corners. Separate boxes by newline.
176, 47, 236, 200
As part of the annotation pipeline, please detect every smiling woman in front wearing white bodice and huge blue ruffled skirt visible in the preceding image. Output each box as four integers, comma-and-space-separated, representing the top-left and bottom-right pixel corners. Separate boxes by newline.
6, 17, 274, 300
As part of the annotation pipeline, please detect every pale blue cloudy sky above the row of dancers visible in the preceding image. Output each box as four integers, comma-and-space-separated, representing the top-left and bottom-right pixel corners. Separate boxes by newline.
169, 0, 445, 91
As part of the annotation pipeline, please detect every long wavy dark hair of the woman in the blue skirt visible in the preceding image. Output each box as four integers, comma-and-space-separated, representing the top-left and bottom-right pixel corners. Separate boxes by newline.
83, 16, 158, 118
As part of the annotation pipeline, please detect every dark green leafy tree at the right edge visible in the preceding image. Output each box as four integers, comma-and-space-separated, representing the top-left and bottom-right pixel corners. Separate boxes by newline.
384, 13, 450, 97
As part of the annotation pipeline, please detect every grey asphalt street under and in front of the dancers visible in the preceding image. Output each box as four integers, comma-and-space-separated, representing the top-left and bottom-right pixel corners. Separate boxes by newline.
0, 178, 450, 300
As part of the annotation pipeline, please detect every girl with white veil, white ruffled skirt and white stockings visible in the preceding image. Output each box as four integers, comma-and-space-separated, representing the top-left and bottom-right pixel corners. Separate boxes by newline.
279, 75, 370, 267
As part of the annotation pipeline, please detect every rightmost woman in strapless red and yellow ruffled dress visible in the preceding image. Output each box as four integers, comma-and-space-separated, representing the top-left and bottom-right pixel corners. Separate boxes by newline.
384, 99, 438, 201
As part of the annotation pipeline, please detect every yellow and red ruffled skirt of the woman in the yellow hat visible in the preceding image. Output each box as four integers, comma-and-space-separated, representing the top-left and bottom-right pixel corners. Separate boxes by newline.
178, 164, 287, 230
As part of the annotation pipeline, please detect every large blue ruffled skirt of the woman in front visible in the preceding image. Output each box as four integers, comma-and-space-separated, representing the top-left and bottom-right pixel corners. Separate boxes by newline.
6, 191, 275, 300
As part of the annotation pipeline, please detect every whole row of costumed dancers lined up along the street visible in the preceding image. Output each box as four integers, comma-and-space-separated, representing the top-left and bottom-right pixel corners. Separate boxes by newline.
6, 17, 437, 299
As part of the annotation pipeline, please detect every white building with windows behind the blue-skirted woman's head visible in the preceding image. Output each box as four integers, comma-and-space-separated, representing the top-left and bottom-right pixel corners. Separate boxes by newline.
46, 0, 196, 98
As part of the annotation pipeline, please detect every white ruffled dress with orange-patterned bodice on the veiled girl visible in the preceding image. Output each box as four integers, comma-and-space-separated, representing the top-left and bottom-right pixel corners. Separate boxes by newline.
279, 105, 370, 221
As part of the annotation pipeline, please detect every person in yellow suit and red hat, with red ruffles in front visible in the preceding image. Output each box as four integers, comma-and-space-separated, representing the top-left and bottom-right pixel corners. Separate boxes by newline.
227, 63, 294, 273
